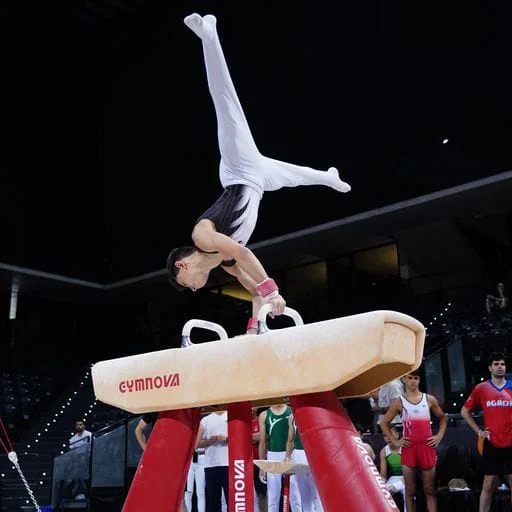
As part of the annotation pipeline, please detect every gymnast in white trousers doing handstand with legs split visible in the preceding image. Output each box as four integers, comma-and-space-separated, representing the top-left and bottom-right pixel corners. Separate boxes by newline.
167, 14, 350, 333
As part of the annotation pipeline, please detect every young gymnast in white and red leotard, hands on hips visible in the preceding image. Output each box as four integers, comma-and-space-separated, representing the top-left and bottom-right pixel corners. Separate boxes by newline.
380, 369, 448, 512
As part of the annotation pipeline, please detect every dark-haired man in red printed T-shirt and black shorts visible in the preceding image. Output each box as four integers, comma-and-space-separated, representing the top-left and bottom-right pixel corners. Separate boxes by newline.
460, 352, 512, 512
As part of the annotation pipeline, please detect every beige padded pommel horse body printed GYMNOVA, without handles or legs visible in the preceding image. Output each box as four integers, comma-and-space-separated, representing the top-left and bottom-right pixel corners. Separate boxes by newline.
92, 311, 425, 414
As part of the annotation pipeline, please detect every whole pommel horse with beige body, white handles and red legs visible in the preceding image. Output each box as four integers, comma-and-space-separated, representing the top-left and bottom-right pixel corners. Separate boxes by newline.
92, 306, 425, 512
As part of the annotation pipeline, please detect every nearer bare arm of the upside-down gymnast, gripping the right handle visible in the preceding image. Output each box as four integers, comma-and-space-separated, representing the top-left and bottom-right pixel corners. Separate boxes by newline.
198, 230, 286, 315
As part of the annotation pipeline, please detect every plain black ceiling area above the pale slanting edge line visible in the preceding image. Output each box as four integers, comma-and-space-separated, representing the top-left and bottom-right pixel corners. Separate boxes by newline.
0, 0, 512, 283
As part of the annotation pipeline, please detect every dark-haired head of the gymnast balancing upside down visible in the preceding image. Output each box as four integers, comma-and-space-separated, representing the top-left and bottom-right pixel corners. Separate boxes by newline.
167, 246, 210, 292
